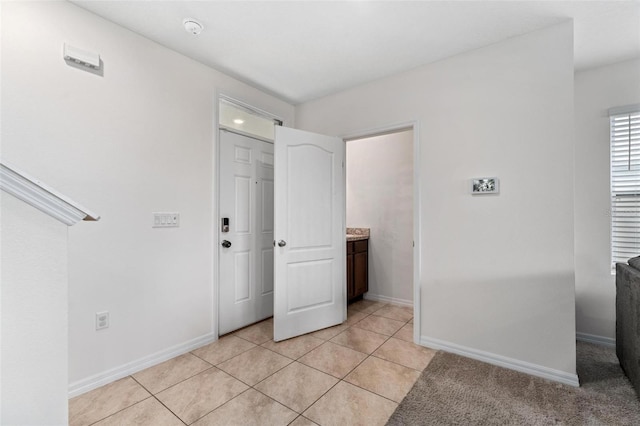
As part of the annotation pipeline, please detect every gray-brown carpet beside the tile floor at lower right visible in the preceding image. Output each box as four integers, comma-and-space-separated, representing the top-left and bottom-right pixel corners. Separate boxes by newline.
387, 342, 640, 426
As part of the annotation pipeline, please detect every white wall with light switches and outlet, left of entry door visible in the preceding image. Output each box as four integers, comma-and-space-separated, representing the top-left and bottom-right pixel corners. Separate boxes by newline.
2, 2, 294, 398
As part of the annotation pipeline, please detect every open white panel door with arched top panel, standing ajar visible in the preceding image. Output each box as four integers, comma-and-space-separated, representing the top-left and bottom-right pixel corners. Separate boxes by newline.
273, 126, 346, 341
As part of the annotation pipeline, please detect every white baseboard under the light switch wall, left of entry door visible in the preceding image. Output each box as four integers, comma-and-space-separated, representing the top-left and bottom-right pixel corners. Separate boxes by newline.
69, 333, 218, 398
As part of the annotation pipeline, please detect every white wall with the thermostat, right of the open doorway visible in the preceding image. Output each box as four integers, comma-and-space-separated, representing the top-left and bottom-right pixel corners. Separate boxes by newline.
296, 22, 576, 383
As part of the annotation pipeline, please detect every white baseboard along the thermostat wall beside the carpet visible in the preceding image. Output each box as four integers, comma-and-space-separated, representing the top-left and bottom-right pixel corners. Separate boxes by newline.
420, 336, 580, 387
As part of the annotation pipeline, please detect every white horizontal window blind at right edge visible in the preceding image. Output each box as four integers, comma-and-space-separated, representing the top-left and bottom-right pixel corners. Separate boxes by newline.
611, 109, 640, 269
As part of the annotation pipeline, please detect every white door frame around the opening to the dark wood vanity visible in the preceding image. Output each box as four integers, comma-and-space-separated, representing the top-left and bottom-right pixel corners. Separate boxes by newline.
341, 121, 422, 344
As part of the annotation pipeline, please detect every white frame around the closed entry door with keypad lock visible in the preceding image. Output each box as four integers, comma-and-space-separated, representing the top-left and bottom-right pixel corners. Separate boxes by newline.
211, 89, 288, 341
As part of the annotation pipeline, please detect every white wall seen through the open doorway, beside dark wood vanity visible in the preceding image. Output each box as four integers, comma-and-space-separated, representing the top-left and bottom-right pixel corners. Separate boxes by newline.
346, 130, 413, 305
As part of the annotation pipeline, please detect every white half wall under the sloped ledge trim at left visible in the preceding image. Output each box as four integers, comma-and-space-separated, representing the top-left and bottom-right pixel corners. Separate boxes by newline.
0, 194, 68, 425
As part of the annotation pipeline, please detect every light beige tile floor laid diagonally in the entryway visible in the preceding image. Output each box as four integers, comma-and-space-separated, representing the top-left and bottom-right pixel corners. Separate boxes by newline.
69, 300, 435, 426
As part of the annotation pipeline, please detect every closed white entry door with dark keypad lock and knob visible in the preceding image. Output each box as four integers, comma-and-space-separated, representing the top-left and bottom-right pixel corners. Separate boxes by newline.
217, 130, 274, 334
